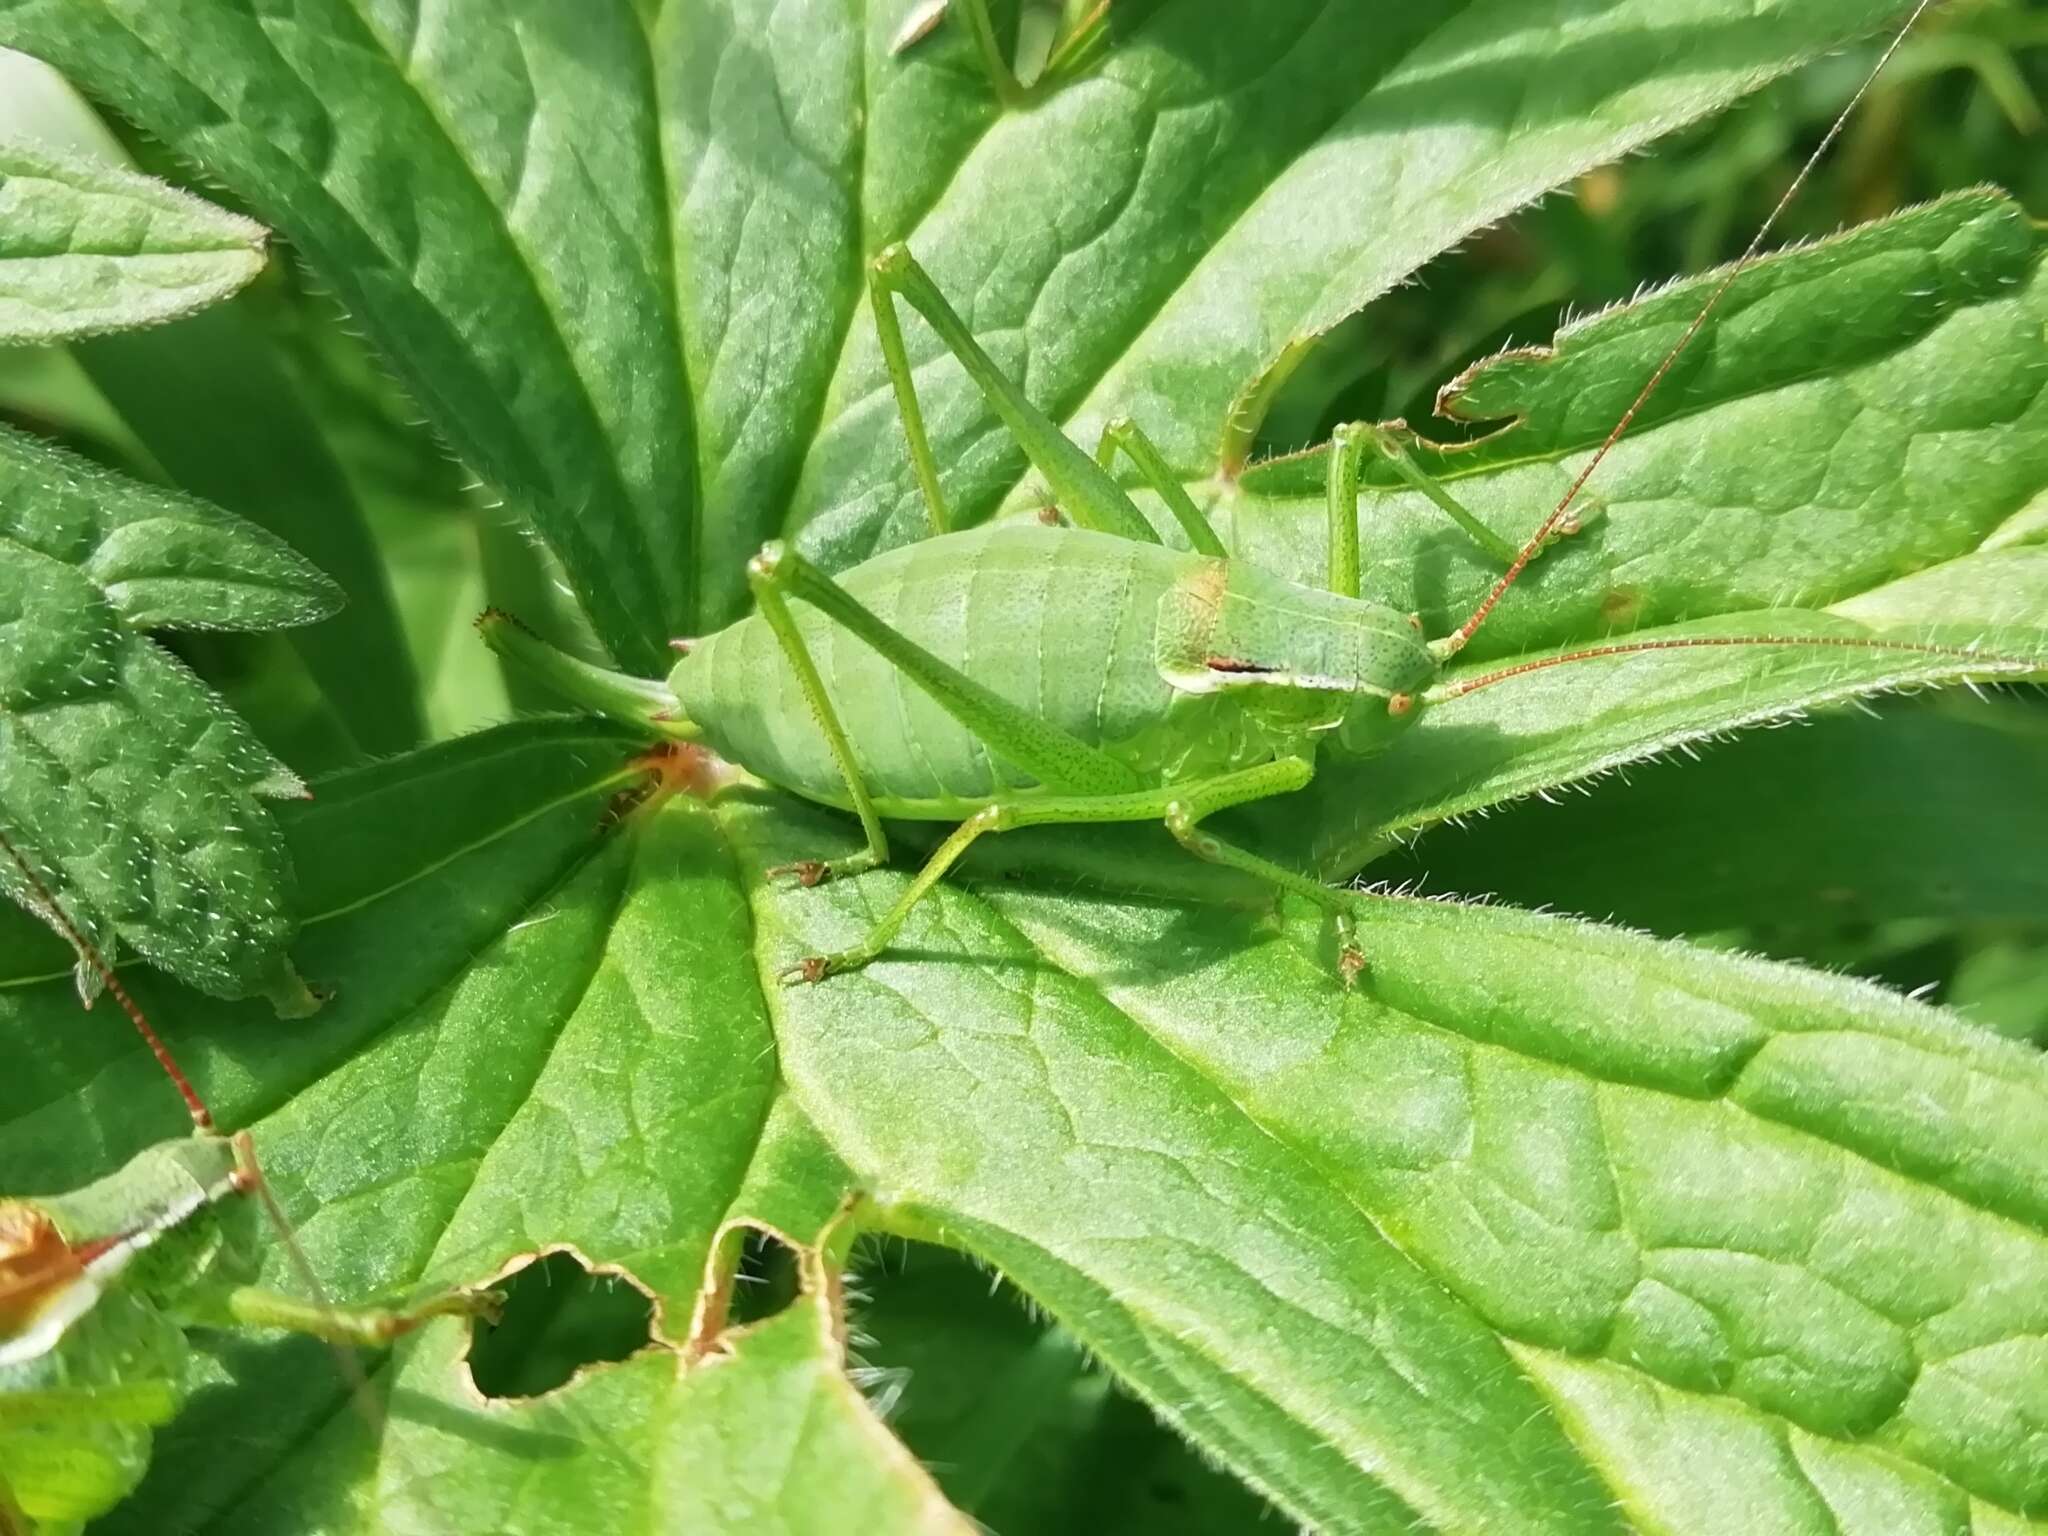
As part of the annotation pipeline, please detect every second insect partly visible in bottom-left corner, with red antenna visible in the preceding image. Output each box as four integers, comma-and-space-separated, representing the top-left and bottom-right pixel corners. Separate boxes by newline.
0, 834, 496, 1536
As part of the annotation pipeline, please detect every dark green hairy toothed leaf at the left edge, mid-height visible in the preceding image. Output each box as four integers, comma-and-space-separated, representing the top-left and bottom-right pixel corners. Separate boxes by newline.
0, 430, 340, 1006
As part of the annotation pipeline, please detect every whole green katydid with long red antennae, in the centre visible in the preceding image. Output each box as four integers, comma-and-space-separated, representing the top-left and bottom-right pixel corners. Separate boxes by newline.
483, 0, 2036, 981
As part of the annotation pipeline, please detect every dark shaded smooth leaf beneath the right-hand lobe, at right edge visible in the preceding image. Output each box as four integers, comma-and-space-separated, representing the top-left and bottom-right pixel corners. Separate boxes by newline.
1372, 705, 2048, 934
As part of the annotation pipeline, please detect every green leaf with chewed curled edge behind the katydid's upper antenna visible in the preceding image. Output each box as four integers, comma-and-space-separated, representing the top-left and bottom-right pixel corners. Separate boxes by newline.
1212, 190, 2048, 659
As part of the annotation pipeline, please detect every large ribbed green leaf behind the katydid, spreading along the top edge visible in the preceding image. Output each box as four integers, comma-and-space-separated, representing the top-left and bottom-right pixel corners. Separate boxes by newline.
0, 0, 1890, 655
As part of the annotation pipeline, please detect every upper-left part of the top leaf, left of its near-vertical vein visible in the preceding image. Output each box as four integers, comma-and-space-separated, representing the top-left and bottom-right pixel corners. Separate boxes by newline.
0, 0, 698, 666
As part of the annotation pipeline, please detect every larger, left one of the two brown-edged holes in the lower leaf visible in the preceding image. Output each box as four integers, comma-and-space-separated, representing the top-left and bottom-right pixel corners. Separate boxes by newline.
469, 1249, 655, 1399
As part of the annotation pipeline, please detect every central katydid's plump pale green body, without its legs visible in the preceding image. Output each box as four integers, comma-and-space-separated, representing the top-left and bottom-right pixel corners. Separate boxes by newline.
670, 522, 1427, 819
